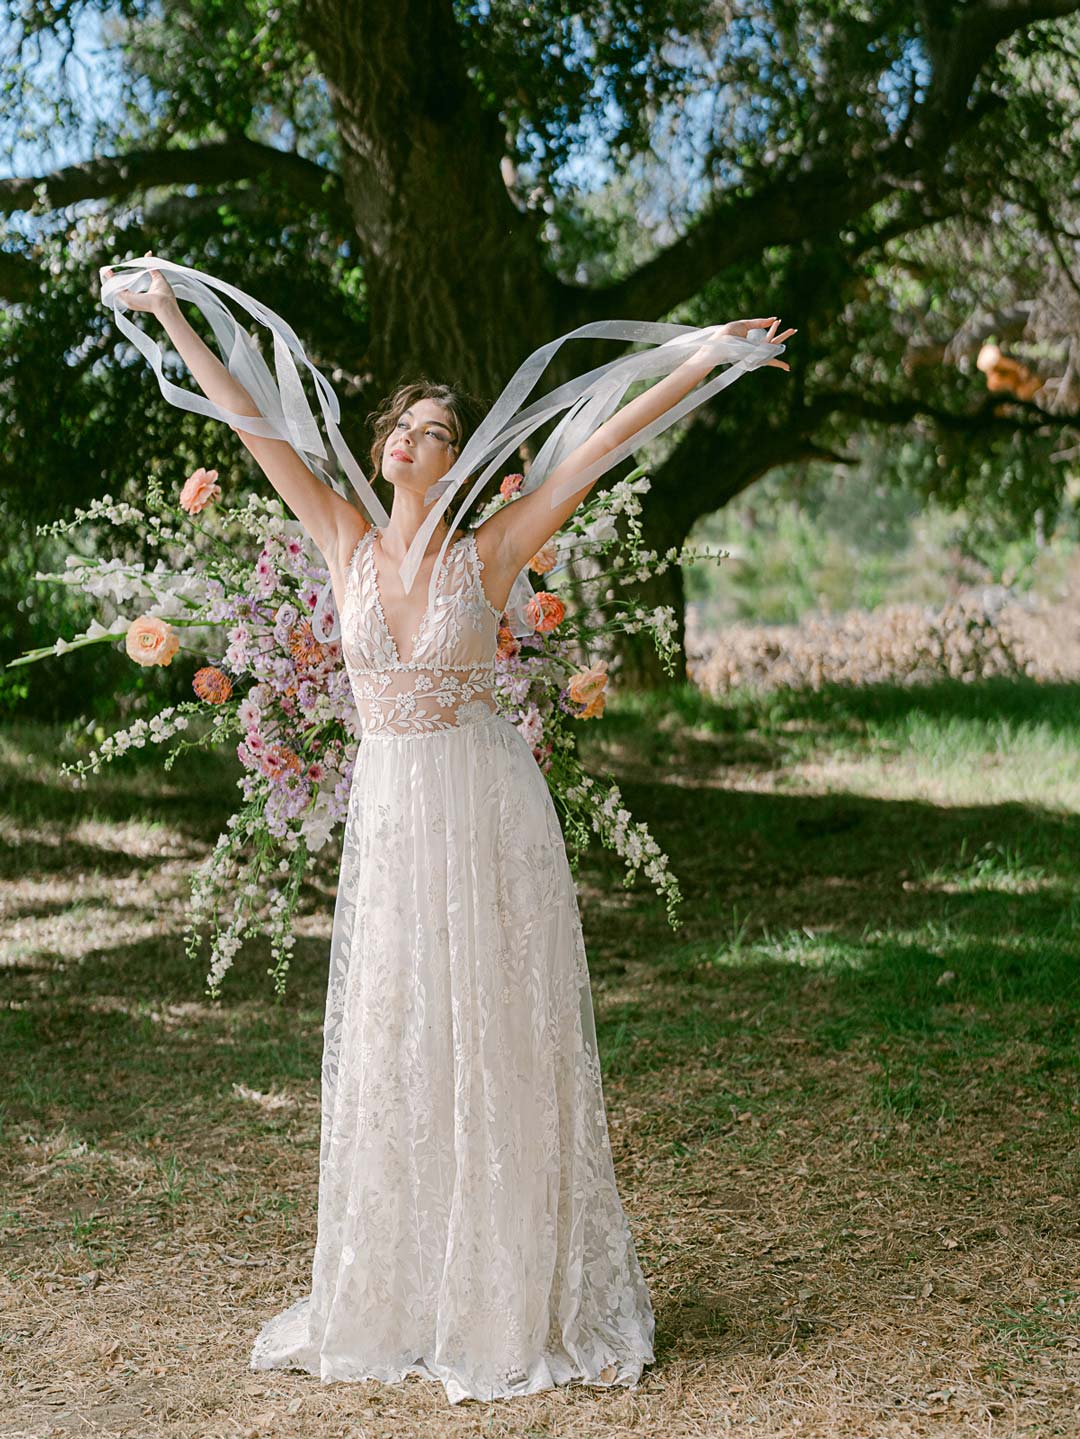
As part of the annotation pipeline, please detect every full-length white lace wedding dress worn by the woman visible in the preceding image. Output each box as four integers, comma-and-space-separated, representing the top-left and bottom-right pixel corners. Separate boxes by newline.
250, 528, 654, 1403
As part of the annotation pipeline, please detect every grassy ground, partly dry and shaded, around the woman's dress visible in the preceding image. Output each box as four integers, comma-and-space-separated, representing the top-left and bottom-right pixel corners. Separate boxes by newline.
0, 682, 1080, 1439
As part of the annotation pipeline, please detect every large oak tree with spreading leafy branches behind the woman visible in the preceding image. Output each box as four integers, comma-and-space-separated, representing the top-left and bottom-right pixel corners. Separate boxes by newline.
0, 0, 1080, 682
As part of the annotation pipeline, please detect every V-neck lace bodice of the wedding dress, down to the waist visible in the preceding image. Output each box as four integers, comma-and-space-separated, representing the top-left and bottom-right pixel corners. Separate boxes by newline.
341, 525, 500, 738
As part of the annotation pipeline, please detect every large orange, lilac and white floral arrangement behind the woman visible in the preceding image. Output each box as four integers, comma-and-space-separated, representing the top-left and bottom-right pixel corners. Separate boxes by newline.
12, 466, 715, 999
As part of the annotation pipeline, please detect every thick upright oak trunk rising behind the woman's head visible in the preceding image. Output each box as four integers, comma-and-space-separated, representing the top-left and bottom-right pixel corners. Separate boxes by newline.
296, 0, 564, 400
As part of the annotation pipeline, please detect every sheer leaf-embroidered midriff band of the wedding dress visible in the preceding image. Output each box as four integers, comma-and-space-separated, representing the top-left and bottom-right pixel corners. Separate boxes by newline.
352, 663, 495, 738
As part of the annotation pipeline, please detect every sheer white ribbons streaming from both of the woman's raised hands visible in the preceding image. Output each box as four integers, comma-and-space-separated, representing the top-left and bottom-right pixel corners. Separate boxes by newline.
101, 256, 785, 639
